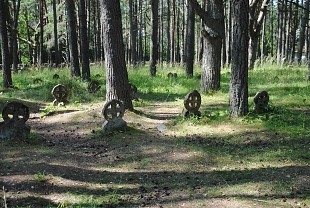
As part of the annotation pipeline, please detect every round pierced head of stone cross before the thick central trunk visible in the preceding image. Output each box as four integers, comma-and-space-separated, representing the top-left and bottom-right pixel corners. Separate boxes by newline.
102, 99, 125, 120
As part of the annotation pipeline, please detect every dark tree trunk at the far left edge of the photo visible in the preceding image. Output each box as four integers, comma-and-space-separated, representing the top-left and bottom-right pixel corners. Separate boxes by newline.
0, 1, 12, 87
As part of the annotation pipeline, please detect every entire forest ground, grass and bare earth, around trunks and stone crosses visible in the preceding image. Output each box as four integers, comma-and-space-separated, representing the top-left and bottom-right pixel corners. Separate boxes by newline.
0, 66, 310, 207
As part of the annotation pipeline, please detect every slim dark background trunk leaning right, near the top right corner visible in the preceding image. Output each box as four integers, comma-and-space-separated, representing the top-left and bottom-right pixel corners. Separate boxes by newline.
297, 0, 309, 64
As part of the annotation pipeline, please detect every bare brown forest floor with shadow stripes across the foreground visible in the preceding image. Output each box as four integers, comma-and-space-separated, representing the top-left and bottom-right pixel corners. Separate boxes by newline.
0, 100, 310, 207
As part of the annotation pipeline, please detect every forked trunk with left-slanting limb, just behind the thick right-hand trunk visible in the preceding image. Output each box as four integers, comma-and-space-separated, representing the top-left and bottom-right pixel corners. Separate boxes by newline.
190, 0, 225, 91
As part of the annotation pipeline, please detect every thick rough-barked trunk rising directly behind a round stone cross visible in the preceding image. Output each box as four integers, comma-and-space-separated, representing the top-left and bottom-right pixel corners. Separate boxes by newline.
101, 0, 133, 109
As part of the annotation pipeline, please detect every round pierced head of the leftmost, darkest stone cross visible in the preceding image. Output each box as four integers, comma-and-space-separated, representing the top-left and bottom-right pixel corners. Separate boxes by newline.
2, 102, 29, 122
